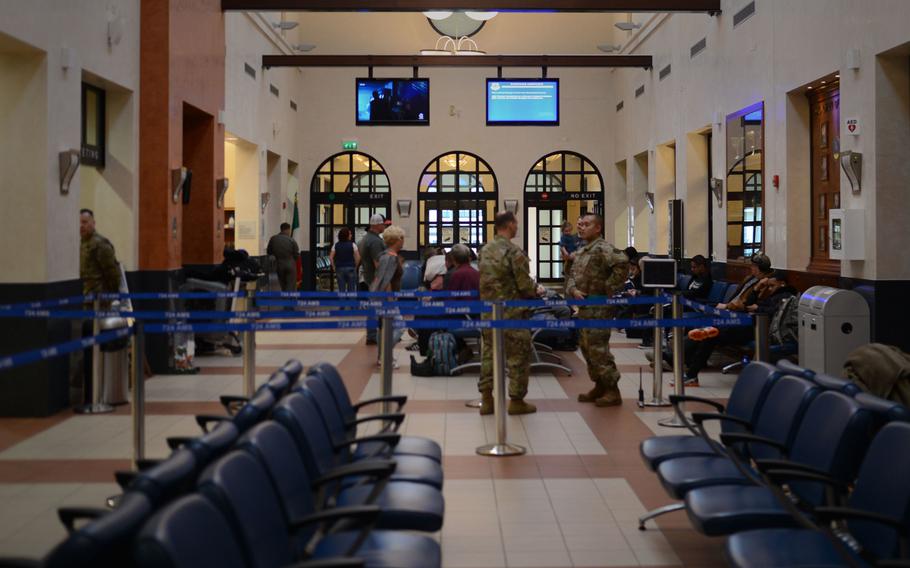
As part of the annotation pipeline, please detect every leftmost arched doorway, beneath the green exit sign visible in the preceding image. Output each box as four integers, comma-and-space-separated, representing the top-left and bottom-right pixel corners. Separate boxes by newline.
310, 152, 392, 290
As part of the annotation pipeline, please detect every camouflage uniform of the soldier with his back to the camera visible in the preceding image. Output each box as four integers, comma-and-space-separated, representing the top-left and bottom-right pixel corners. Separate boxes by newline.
477, 235, 537, 400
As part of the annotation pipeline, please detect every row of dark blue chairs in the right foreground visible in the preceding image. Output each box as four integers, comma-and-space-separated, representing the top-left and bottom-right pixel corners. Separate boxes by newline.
639, 361, 910, 568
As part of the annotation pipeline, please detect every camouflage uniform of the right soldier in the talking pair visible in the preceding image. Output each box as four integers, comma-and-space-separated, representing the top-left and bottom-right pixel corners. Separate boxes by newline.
566, 237, 629, 388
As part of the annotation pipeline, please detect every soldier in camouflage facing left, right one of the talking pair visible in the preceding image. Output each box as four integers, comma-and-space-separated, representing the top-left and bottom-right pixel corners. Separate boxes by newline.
566, 214, 629, 406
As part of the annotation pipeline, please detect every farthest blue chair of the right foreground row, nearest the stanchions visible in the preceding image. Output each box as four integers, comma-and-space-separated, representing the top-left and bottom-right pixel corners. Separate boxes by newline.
639, 362, 782, 471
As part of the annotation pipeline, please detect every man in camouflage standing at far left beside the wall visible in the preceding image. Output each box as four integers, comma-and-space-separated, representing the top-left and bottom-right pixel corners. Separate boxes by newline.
79, 209, 120, 404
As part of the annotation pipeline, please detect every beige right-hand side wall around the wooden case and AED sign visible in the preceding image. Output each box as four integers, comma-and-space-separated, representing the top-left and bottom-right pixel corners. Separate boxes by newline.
607, 0, 910, 278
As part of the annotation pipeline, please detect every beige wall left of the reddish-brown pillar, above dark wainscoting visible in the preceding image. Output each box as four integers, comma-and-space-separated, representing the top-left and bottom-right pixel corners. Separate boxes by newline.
0, 0, 139, 282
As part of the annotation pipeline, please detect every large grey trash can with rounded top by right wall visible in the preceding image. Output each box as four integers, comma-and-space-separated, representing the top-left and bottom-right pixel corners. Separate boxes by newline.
799, 286, 870, 376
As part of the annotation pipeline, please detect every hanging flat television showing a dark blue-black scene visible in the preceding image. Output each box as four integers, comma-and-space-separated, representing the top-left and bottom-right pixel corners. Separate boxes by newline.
357, 78, 430, 126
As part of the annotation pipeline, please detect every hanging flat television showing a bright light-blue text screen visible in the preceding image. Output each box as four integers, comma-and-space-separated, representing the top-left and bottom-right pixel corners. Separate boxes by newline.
487, 79, 559, 126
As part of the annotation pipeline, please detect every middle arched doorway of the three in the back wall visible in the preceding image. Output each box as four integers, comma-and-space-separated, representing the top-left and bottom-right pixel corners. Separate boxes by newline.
417, 151, 499, 252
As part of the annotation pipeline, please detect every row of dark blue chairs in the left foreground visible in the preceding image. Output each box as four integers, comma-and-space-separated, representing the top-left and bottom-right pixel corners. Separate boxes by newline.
0, 361, 445, 568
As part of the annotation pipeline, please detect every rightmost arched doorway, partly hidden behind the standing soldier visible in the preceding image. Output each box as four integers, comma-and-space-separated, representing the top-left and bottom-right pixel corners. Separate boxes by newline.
524, 151, 604, 282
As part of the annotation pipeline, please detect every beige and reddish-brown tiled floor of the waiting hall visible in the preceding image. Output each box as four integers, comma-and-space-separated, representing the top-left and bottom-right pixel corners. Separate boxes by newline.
0, 324, 736, 567
